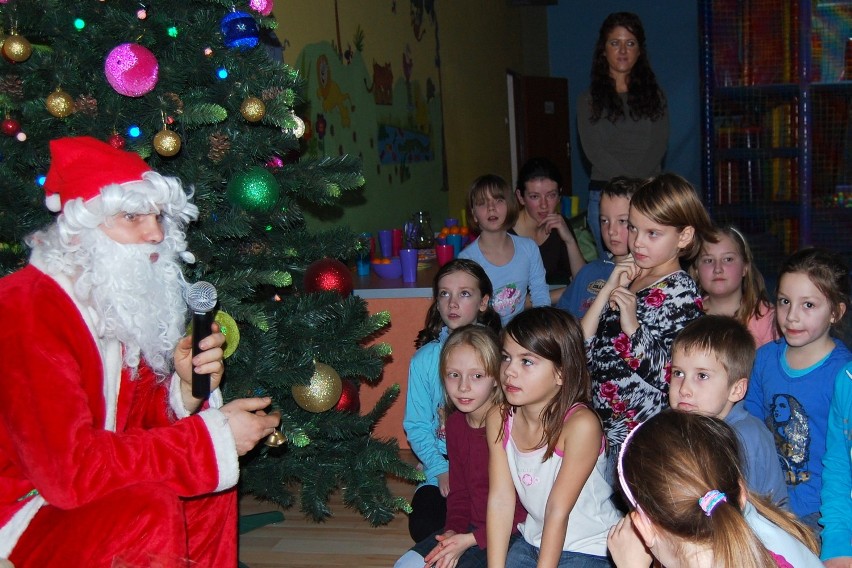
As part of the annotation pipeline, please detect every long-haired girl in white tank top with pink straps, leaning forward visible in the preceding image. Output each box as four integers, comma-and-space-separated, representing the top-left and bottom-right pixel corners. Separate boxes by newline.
486, 307, 619, 568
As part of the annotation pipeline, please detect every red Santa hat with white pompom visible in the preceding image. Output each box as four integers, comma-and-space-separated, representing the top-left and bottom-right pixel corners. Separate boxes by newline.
44, 136, 151, 213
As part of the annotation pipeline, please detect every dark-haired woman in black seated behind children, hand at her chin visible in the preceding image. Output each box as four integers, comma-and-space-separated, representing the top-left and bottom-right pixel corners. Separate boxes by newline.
509, 158, 586, 301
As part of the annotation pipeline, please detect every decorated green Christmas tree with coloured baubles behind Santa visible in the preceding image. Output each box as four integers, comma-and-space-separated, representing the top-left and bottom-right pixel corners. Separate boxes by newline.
0, 0, 420, 524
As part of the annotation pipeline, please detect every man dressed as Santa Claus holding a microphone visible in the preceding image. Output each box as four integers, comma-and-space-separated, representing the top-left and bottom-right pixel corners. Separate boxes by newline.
0, 137, 278, 568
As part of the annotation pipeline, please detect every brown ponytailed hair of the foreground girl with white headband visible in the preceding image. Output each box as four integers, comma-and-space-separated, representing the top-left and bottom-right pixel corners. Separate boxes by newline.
618, 410, 815, 568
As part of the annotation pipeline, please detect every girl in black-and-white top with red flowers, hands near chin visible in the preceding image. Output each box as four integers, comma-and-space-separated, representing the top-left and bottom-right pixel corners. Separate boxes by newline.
582, 174, 716, 474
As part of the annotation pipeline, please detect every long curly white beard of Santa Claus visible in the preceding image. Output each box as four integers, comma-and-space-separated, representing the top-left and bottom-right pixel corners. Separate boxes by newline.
75, 229, 187, 377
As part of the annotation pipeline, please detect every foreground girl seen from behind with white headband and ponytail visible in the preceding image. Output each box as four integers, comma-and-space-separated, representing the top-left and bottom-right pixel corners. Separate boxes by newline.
607, 410, 822, 568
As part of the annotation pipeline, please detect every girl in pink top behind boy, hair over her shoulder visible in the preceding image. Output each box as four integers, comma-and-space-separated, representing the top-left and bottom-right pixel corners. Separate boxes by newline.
689, 226, 778, 347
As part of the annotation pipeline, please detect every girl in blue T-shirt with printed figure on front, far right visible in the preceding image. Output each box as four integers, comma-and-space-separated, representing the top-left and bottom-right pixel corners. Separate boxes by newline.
745, 248, 852, 531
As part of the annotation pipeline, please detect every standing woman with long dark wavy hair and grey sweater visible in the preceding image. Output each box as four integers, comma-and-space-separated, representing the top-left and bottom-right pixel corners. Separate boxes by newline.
577, 12, 669, 257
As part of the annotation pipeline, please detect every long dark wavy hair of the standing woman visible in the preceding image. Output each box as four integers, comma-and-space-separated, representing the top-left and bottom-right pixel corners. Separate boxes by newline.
589, 12, 666, 122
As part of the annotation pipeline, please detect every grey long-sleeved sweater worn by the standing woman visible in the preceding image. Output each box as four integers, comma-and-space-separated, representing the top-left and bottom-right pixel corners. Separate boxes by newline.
577, 91, 669, 181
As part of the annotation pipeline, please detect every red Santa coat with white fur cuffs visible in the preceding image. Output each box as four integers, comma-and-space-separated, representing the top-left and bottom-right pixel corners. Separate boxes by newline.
0, 265, 238, 555
